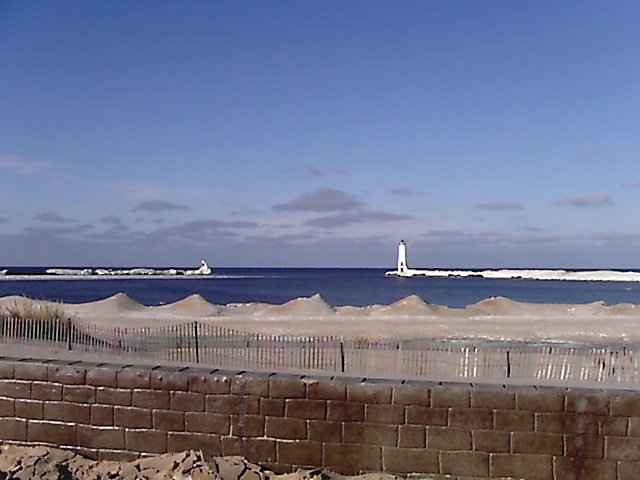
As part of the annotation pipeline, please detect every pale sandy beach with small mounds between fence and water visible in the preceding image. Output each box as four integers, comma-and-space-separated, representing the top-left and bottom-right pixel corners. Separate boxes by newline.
0, 293, 640, 344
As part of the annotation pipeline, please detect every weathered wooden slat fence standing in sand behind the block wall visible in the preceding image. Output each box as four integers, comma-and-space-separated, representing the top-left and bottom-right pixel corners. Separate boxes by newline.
0, 316, 640, 387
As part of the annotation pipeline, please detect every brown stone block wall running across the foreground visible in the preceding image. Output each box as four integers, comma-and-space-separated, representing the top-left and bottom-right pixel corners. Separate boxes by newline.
0, 358, 640, 480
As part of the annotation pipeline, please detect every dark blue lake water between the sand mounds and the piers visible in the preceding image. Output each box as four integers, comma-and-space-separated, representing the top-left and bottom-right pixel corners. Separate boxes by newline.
0, 268, 640, 307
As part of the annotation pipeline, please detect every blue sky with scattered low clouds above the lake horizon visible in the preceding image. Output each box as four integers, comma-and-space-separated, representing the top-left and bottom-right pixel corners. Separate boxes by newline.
0, 0, 640, 268
